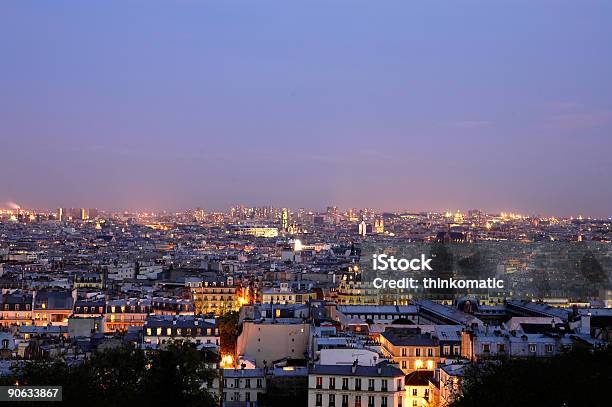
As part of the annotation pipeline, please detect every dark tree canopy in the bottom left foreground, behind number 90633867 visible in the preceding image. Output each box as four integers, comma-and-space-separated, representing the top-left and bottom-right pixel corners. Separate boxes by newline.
0, 344, 216, 407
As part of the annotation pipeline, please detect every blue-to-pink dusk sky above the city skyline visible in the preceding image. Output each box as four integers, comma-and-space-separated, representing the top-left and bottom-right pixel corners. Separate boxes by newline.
0, 0, 612, 217
